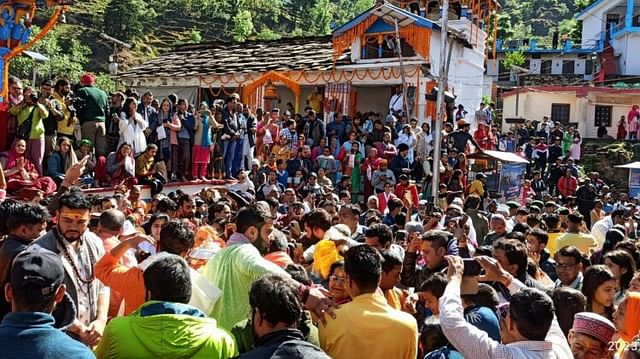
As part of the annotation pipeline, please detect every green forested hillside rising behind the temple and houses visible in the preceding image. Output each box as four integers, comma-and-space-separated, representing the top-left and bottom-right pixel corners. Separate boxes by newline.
16, 0, 594, 86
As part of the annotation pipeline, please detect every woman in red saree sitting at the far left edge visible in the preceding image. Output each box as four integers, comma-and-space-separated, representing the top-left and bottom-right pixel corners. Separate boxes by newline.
4, 140, 57, 196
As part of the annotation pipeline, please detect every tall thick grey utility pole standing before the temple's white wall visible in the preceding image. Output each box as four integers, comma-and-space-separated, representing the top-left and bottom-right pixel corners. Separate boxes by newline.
431, 0, 451, 206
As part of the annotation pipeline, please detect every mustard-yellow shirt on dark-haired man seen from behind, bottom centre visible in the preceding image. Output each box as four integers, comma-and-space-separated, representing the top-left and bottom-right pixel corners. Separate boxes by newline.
318, 293, 418, 359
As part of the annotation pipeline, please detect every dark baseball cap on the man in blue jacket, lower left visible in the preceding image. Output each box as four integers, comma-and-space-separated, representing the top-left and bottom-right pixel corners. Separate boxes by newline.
11, 245, 64, 296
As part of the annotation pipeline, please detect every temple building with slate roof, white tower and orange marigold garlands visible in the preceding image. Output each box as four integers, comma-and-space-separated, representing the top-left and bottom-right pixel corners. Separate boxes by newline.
118, 0, 499, 126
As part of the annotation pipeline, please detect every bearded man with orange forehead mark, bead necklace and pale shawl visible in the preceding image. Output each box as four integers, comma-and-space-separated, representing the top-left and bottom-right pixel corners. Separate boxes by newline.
34, 191, 109, 347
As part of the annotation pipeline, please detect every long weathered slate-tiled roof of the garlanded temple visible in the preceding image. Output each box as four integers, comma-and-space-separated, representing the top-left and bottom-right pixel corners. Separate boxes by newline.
118, 36, 351, 79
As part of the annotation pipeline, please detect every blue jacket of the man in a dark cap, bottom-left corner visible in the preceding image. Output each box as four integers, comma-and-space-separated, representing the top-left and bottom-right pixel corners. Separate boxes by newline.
0, 312, 95, 359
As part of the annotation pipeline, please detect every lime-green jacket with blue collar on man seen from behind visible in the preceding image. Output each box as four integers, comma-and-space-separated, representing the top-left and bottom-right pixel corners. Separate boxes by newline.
95, 301, 238, 359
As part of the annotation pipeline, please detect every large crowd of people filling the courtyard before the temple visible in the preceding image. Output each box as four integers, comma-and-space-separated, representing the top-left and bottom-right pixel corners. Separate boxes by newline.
0, 74, 640, 359
